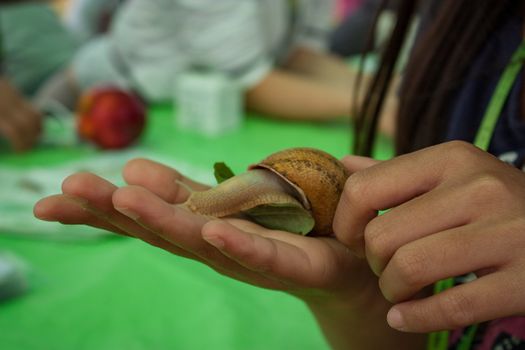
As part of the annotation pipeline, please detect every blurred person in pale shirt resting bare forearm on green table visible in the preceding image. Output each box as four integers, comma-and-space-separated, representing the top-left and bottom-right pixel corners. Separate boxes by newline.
60, 0, 388, 126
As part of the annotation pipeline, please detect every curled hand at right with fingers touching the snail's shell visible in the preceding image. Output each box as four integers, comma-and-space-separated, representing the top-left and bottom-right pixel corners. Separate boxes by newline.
334, 142, 525, 332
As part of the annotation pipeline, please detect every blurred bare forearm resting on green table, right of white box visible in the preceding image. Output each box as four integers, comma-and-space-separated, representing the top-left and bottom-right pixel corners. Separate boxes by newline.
246, 70, 352, 121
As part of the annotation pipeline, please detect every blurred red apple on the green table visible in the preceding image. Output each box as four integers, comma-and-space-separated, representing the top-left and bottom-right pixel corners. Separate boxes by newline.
77, 86, 146, 149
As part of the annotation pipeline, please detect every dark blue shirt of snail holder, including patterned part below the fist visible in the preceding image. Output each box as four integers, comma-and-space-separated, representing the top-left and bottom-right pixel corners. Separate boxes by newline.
424, 9, 525, 350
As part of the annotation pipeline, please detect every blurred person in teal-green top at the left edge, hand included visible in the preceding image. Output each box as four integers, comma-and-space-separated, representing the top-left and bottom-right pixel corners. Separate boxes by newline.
0, 1, 76, 152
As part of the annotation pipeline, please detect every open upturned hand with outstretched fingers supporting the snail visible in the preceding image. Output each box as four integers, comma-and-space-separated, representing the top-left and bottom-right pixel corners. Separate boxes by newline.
35, 160, 374, 301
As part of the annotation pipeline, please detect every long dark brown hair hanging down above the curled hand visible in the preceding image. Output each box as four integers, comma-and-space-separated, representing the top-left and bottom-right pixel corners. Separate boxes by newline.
355, 0, 517, 155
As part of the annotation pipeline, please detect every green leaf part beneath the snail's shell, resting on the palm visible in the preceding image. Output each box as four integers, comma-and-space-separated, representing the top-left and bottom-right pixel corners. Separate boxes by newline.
244, 203, 315, 235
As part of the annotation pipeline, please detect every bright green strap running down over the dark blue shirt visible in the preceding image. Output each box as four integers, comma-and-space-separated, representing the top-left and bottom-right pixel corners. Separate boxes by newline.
427, 40, 525, 350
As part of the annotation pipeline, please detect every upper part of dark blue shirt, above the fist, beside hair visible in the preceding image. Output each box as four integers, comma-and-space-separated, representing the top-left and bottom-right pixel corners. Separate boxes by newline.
446, 18, 525, 167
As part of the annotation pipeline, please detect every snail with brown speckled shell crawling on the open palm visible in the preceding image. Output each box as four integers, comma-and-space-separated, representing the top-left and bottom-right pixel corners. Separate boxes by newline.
183, 148, 349, 235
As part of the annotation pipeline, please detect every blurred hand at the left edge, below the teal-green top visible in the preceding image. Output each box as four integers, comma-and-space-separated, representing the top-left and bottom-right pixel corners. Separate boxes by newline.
0, 78, 42, 152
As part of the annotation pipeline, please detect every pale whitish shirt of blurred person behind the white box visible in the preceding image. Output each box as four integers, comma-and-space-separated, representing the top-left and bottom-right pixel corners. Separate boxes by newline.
74, 0, 333, 101
